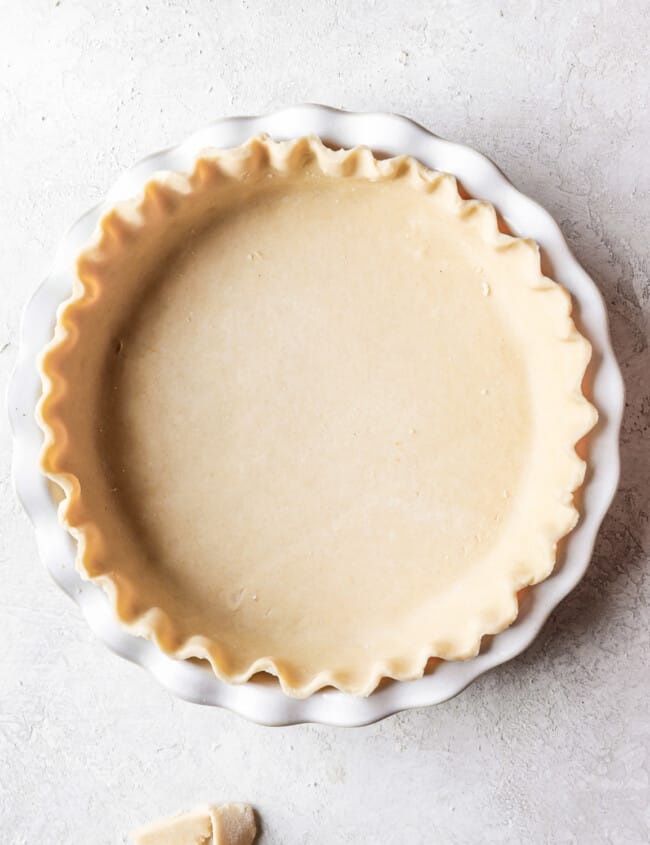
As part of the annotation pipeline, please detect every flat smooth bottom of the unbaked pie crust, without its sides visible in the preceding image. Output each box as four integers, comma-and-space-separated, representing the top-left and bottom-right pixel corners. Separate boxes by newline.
102, 182, 532, 660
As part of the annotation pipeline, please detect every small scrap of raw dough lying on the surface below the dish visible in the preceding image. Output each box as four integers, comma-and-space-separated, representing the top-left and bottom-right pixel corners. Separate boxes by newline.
131, 804, 257, 845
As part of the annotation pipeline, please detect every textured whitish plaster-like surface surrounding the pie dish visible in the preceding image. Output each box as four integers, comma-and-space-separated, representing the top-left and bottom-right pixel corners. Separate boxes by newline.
0, 0, 650, 845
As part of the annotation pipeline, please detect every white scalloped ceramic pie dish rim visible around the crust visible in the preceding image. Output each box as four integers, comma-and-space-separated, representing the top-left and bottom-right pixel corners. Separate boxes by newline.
8, 105, 624, 726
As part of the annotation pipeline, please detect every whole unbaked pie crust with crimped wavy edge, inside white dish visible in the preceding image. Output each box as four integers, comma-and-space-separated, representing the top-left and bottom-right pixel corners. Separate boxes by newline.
34, 137, 595, 697
